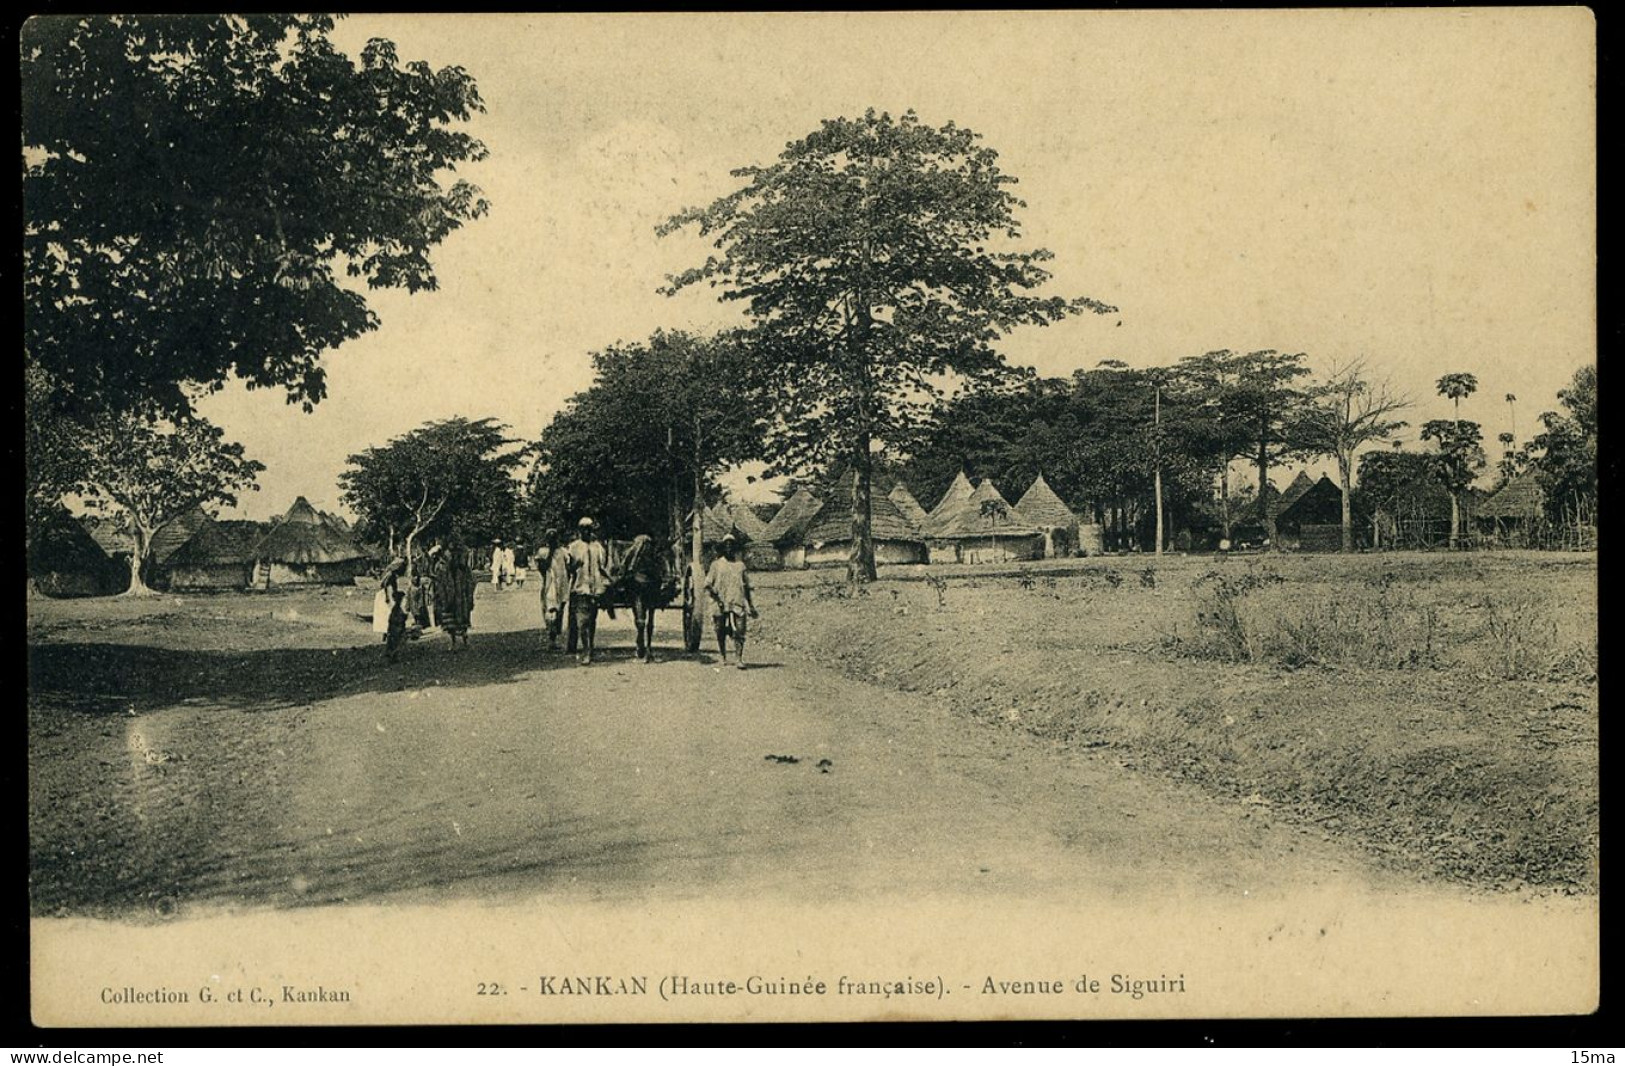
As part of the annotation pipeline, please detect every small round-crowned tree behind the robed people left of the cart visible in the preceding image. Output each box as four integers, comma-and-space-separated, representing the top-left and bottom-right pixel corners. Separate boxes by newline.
338, 418, 520, 577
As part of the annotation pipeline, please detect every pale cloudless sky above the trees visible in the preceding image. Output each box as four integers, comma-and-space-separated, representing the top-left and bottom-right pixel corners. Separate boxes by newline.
184, 8, 1596, 518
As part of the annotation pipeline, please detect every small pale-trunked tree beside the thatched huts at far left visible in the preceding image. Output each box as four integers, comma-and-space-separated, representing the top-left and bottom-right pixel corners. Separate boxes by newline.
78, 406, 265, 596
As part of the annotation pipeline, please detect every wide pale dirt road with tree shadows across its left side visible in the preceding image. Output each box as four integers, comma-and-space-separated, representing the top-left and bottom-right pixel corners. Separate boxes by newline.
31, 587, 1410, 915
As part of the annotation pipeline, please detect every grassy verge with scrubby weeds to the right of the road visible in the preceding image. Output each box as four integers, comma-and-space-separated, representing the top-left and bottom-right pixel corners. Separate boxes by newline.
762, 554, 1597, 892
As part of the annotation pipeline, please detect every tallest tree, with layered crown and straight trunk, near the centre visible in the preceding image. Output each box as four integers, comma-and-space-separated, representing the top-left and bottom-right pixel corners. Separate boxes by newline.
661, 111, 1115, 582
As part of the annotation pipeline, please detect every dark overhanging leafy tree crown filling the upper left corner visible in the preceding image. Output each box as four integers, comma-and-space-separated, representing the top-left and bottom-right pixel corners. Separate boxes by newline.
21, 15, 486, 418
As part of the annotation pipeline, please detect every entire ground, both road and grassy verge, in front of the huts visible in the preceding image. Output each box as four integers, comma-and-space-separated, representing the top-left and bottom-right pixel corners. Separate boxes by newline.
29, 556, 1596, 920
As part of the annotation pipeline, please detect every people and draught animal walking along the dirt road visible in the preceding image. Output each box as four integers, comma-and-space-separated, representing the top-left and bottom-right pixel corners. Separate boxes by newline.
374, 518, 757, 670
